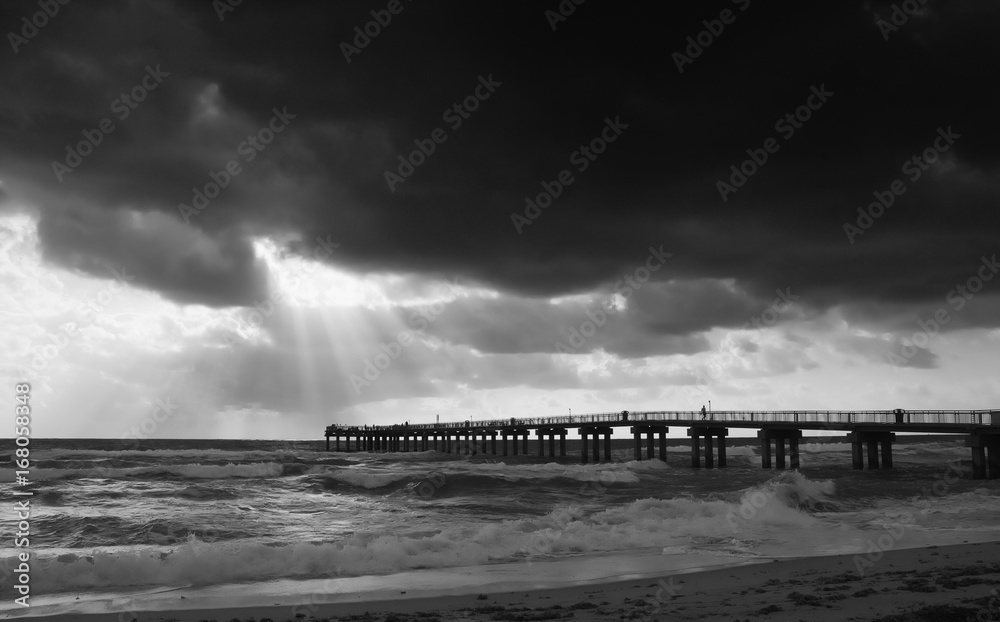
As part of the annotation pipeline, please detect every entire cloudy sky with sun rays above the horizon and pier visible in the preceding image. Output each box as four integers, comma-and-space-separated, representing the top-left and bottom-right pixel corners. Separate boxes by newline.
0, 0, 1000, 438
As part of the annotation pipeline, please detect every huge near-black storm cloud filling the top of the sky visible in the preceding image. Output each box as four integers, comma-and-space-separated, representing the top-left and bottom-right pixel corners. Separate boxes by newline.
0, 2, 1000, 330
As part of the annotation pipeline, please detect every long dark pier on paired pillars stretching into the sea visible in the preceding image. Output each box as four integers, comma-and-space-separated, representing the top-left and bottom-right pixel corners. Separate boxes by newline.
326, 409, 1000, 479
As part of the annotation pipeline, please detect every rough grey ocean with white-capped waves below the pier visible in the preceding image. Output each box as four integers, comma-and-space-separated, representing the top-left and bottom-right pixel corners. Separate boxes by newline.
0, 436, 1000, 614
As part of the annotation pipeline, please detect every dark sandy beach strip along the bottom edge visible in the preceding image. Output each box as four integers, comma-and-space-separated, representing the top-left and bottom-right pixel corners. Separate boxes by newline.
15, 542, 1000, 622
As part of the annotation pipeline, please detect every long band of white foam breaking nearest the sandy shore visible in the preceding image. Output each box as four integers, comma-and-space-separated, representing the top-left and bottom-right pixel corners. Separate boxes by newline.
19, 473, 833, 592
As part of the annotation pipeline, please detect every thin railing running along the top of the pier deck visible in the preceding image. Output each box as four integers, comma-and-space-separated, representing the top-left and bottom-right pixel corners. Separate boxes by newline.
327, 410, 1000, 431
